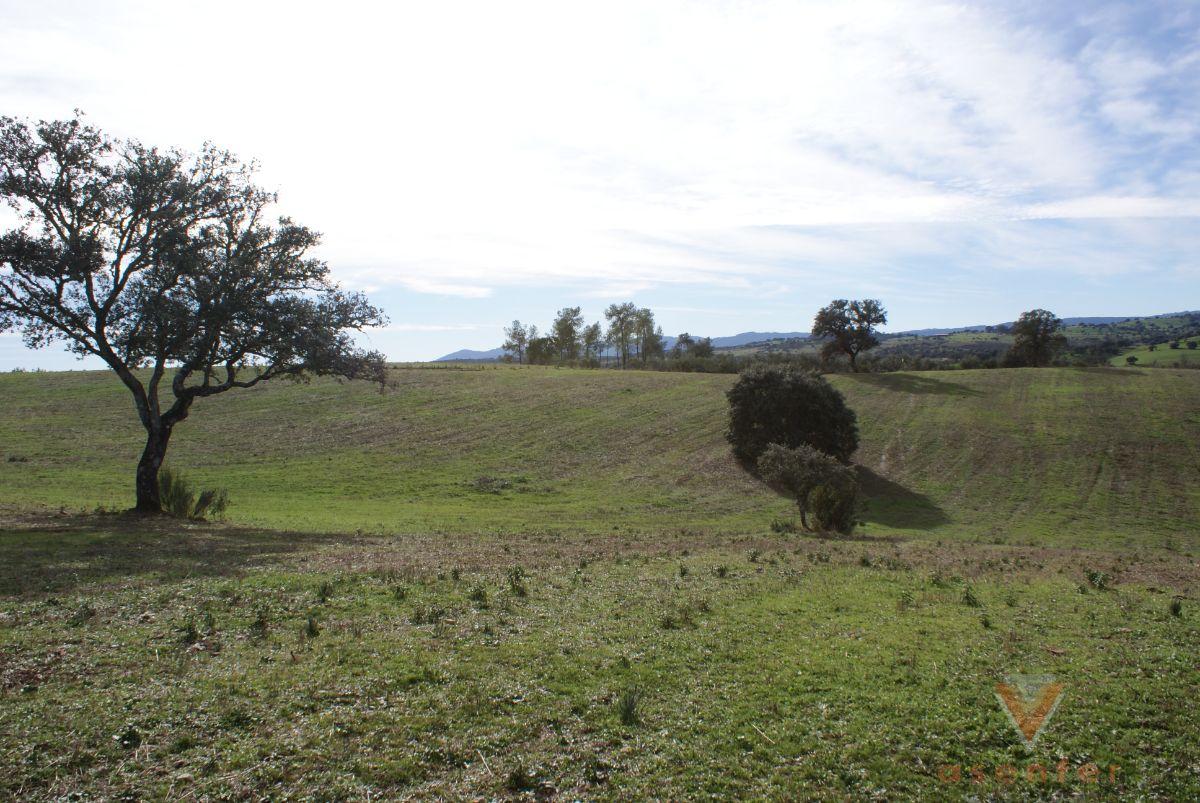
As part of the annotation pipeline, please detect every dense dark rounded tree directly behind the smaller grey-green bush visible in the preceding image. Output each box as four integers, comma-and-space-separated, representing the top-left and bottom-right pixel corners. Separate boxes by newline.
726, 365, 858, 466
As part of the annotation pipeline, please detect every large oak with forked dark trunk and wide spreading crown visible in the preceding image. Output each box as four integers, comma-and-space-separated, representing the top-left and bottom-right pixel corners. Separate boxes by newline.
0, 116, 385, 513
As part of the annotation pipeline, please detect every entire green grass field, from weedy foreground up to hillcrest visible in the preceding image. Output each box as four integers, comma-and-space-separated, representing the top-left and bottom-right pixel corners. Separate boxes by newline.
0, 367, 1200, 801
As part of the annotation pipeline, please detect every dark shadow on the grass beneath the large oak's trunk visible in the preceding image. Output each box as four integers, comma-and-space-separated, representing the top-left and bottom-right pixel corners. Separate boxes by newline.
0, 515, 355, 597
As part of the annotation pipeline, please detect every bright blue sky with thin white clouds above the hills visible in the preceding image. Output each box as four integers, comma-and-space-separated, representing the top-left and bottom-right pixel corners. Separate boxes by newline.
0, 0, 1200, 370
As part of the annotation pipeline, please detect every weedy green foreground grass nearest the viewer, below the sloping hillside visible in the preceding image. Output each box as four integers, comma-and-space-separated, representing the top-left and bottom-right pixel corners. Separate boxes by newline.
0, 516, 1200, 801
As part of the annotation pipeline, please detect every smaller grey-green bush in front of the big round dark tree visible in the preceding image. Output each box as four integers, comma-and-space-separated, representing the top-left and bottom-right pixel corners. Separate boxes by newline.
757, 443, 858, 532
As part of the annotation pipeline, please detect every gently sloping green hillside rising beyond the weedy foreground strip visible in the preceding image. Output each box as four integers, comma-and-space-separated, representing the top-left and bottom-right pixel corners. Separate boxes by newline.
0, 366, 1200, 544
